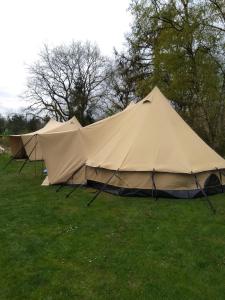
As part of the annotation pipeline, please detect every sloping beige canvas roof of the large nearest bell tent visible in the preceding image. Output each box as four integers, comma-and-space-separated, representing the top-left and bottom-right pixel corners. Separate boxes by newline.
83, 87, 225, 173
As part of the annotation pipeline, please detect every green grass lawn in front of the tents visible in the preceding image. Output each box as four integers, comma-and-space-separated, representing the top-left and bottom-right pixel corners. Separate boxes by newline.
0, 156, 225, 300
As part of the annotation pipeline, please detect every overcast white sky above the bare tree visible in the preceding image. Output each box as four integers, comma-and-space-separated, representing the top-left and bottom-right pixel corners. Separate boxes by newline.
0, 0, 131, 114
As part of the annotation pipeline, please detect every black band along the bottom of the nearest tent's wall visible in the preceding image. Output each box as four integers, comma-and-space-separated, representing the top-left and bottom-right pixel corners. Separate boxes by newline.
87, 181, 225, 199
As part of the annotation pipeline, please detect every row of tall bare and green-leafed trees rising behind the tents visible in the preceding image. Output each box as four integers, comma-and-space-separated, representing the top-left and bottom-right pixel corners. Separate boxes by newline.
0, 0, 225, 154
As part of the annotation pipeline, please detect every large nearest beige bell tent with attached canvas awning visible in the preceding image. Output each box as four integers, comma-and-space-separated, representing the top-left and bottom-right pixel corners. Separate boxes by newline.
40, 88, 225, 198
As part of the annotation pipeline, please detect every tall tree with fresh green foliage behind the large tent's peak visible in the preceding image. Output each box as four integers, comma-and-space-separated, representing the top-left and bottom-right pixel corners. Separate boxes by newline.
128, 0, 225, 153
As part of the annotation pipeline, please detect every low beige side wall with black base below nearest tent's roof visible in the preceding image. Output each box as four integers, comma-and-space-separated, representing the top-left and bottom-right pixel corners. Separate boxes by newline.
86, 167, 225, 198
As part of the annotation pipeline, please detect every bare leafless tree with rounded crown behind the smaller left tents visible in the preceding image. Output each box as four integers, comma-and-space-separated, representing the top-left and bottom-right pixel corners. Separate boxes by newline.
24, 42, 108, 124
